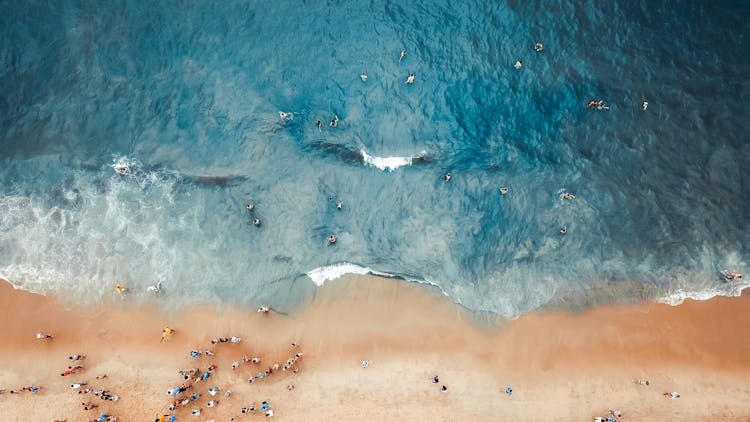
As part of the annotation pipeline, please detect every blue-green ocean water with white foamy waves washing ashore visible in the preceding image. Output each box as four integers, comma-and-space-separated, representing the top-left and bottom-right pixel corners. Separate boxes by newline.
0, 0, 750, 317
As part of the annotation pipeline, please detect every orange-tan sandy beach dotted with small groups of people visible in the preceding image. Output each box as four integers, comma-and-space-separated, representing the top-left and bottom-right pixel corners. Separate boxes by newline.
0, 276, 750, 421
